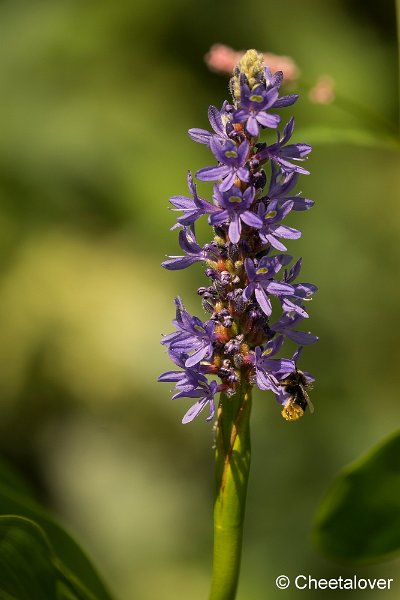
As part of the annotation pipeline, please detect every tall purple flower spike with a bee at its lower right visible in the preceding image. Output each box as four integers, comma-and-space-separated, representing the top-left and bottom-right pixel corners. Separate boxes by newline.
159, 50, 318, 423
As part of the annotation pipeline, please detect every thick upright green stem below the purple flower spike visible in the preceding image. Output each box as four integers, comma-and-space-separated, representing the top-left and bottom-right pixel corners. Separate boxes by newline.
209, 382, 251, 600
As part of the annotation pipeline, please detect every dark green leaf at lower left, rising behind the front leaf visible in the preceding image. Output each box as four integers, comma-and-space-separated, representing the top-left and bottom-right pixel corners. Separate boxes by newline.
0, 462, 111, 600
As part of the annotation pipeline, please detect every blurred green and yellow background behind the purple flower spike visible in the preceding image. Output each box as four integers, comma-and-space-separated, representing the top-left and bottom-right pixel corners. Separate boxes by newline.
0, 0, 400, 600
